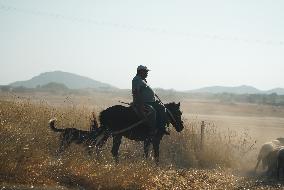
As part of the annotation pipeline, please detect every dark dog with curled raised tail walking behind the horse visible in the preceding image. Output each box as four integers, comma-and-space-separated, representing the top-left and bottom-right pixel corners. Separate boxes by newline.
49, 114, 98, 154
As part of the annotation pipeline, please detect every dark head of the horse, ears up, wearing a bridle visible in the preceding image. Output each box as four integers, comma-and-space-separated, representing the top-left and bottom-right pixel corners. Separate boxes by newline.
165, 102, 184, 132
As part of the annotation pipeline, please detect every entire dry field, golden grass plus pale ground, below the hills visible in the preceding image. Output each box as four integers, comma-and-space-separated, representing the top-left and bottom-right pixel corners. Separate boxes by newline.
0, 93, 284, 189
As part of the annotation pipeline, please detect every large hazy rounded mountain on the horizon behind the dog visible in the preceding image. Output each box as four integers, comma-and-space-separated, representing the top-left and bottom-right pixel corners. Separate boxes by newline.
10, 71, 117, 90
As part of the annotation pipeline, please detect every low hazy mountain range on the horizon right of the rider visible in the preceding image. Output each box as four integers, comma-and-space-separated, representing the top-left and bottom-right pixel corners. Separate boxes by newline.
187, 85, 284, 95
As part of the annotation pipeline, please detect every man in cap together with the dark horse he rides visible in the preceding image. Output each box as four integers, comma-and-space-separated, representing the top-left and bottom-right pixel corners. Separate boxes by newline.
95, 65, 184, 164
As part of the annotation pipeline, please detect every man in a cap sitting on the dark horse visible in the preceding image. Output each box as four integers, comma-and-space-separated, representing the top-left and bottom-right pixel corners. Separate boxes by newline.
132, 65, 169, 134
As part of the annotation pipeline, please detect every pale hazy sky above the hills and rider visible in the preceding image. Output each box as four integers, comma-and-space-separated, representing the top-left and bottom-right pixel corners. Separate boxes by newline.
0, 0, 284, 90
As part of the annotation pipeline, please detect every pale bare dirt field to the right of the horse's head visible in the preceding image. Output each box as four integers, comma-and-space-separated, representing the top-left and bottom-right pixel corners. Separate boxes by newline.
183, 100, 284, 149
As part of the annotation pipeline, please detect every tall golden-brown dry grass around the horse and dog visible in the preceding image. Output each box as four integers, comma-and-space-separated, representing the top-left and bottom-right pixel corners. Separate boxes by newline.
0, 97, 281, 189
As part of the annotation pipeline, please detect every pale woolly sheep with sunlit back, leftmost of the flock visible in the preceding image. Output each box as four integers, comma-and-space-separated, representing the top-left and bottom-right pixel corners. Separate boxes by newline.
254, 138, 283, 172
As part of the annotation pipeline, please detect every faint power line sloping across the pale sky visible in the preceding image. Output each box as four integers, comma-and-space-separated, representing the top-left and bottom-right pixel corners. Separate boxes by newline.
0, 4, 284, 46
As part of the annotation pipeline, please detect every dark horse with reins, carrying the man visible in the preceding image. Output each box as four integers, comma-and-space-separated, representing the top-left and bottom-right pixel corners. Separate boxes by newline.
96, 102, 184, 164
